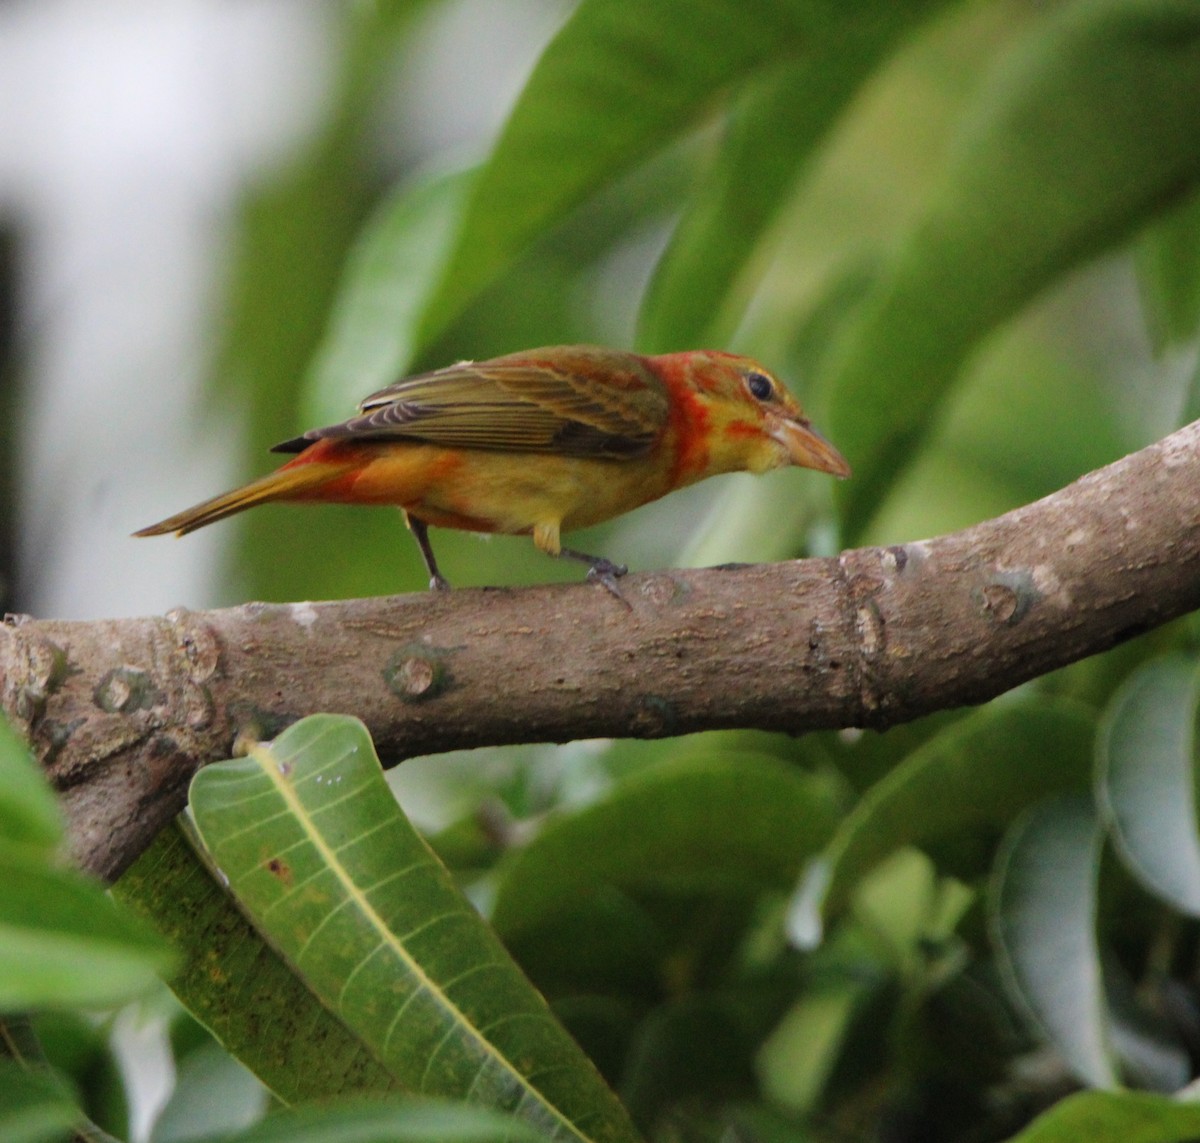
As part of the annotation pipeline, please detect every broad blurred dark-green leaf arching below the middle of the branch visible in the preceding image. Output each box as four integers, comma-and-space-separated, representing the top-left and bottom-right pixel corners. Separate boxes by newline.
492, 752, 838, 941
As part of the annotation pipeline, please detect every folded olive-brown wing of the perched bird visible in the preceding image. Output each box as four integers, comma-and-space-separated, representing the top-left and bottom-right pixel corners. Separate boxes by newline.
276, 347, 668, 459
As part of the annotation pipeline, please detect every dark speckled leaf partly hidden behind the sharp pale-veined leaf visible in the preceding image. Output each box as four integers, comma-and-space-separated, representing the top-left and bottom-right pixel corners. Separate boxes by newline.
113, 825, 398, 1103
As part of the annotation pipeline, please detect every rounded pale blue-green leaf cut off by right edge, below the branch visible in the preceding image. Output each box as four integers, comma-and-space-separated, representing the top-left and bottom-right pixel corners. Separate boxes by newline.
1096, 656, 1200, 916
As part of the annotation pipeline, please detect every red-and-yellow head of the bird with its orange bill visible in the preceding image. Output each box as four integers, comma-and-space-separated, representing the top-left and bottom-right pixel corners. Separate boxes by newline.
656, 349, 850, 477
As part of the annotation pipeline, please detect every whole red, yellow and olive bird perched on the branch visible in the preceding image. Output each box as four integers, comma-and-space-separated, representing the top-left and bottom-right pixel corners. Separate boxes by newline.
136, 346, 850, 590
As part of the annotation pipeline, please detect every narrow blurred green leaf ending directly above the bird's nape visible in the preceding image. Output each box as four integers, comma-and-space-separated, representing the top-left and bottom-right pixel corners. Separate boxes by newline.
638, 4, 937, 353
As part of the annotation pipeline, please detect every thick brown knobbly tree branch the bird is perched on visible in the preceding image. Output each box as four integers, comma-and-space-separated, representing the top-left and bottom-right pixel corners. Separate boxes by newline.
7, 421, 1200, 876
